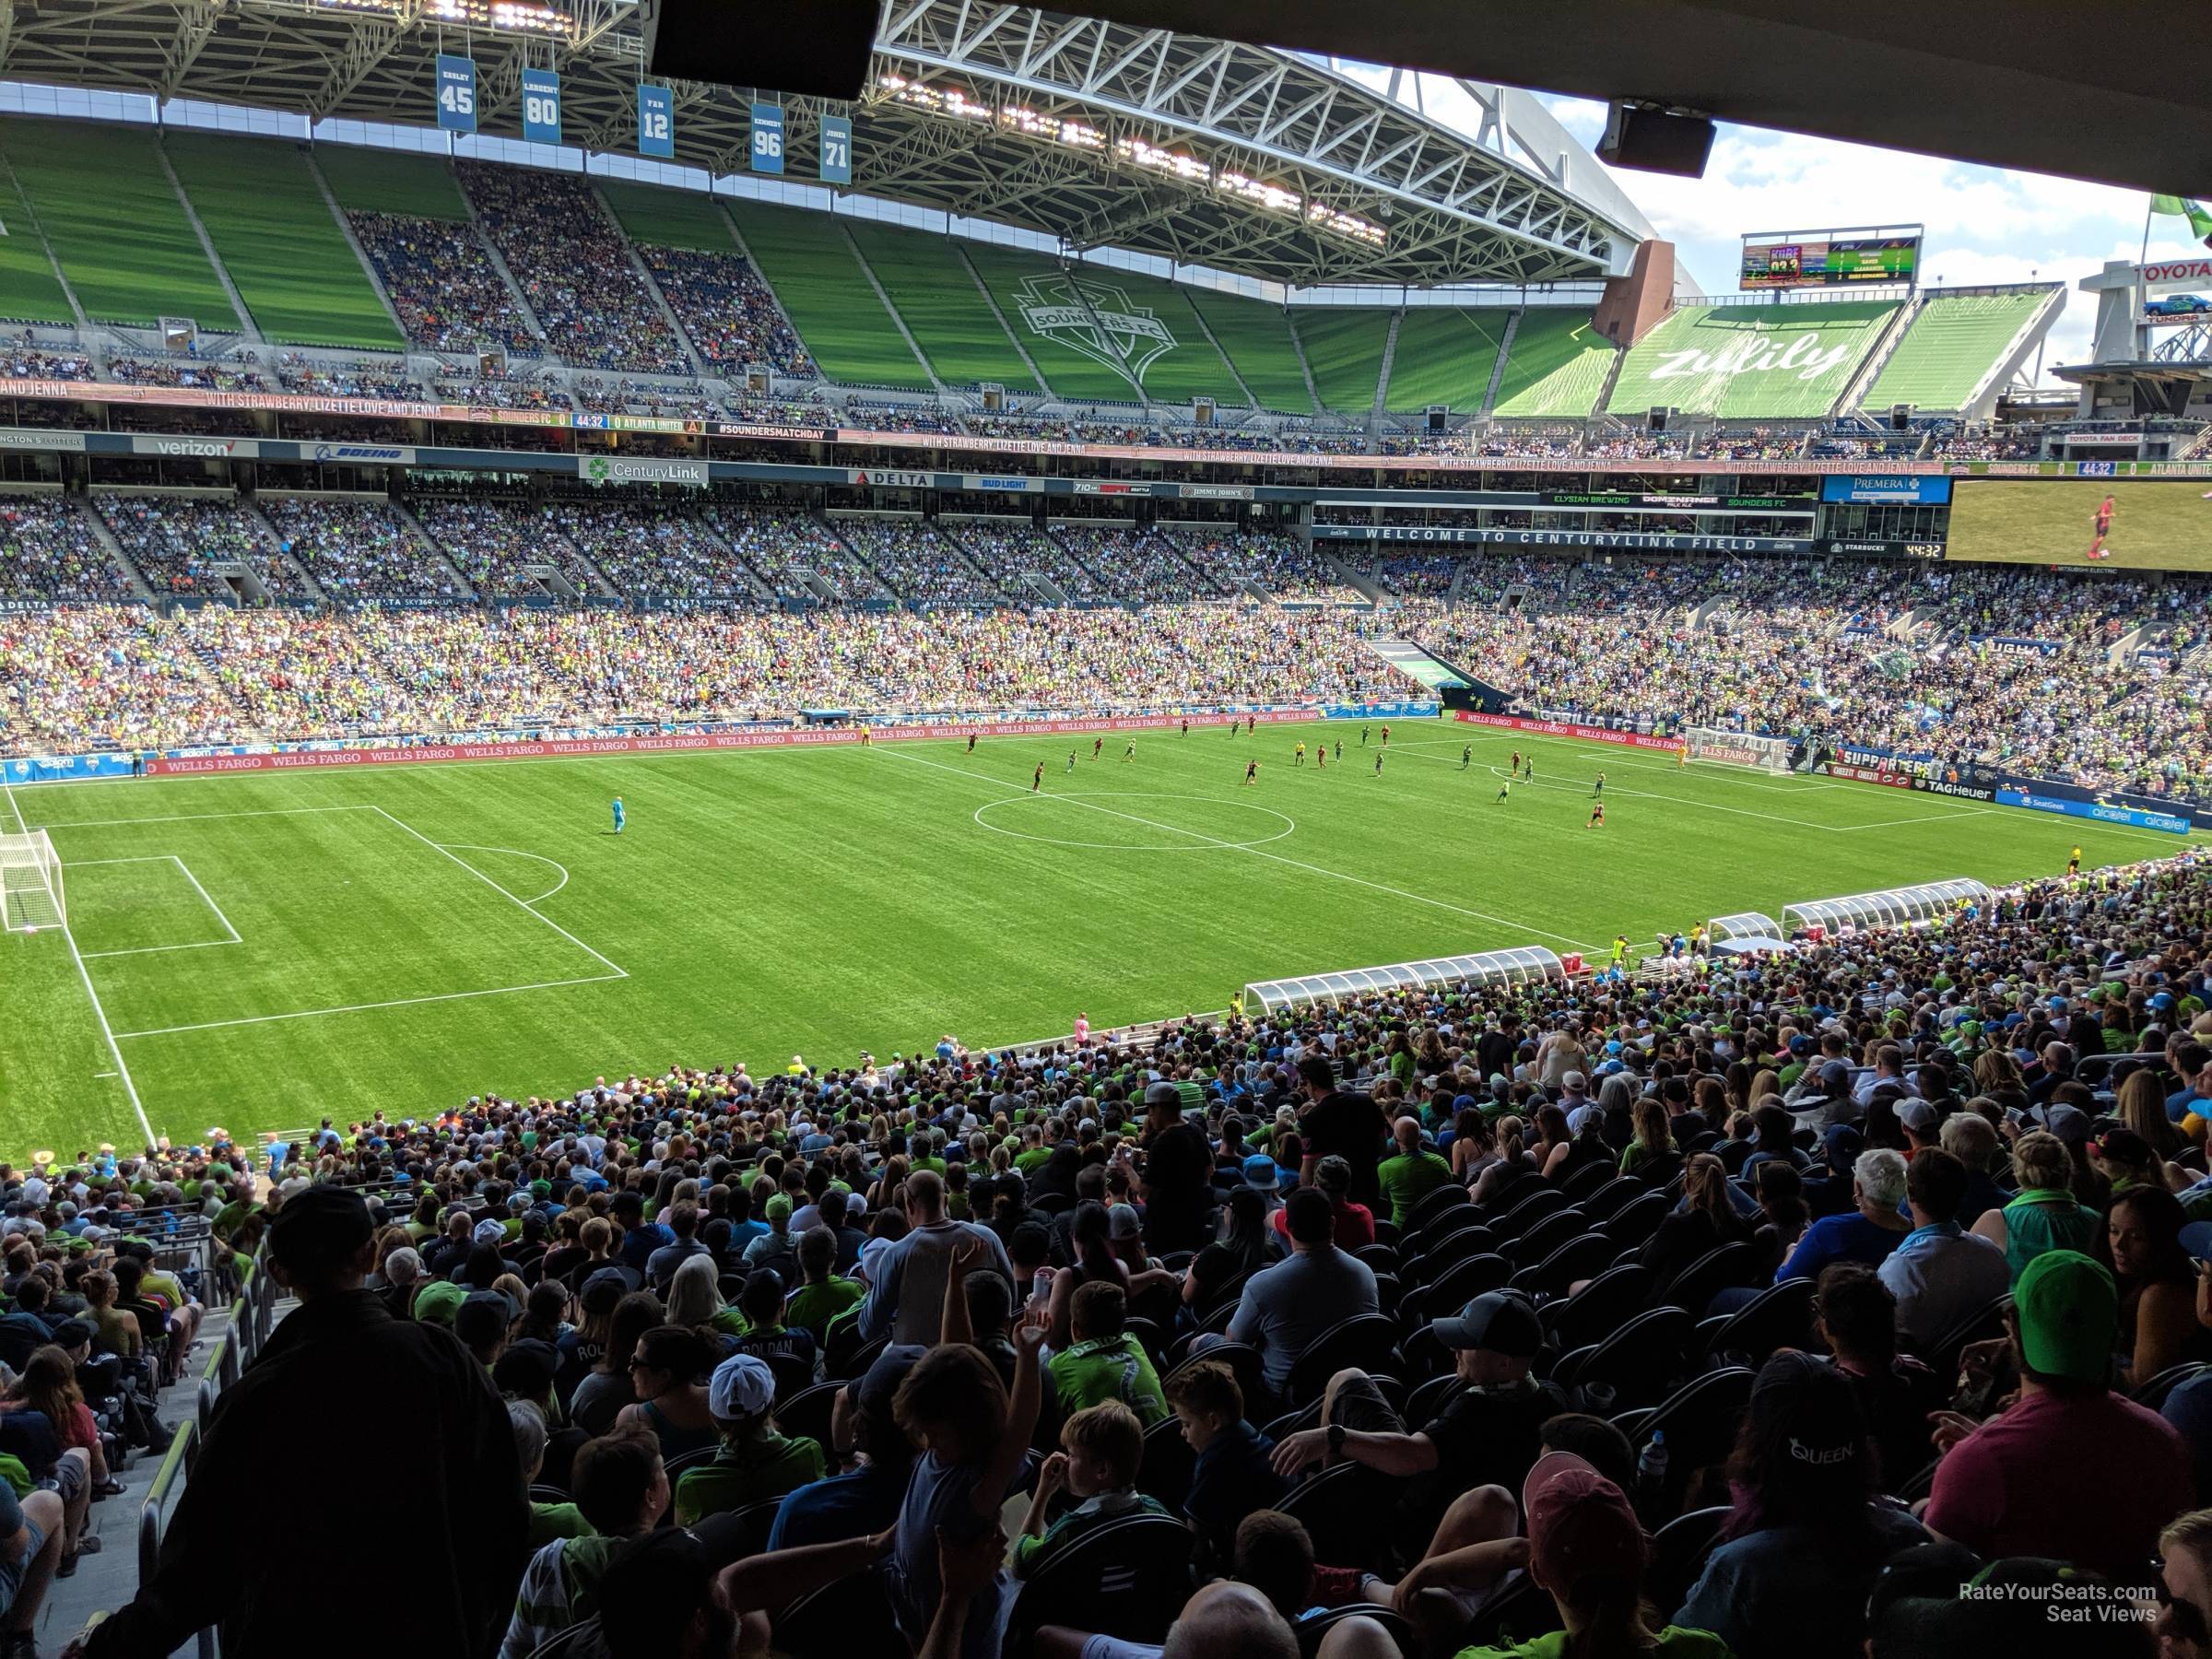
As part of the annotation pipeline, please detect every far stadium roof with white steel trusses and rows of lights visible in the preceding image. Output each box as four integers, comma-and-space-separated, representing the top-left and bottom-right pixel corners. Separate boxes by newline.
0, 0, 1648, 288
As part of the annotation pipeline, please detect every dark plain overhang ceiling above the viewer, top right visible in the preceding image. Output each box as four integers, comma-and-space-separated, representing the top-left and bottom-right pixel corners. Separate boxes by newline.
1018, 0, 2212, 197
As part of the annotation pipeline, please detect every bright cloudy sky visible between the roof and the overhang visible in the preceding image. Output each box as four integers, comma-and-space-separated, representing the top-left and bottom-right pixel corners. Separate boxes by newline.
1327, 76, 2203, 378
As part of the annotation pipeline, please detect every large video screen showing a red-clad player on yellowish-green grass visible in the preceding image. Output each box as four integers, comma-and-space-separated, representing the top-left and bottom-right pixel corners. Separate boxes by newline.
1948, 477, 2212, 571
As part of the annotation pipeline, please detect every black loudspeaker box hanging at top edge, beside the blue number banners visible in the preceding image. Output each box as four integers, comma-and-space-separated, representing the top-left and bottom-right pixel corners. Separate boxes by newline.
640, 0, 878, 100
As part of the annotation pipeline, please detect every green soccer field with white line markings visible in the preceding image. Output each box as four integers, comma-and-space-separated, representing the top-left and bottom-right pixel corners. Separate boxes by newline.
0, 721, 2177, 1161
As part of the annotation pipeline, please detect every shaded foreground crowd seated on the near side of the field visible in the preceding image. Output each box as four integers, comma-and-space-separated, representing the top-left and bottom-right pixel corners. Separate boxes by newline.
13, 852, 2212, 1659
